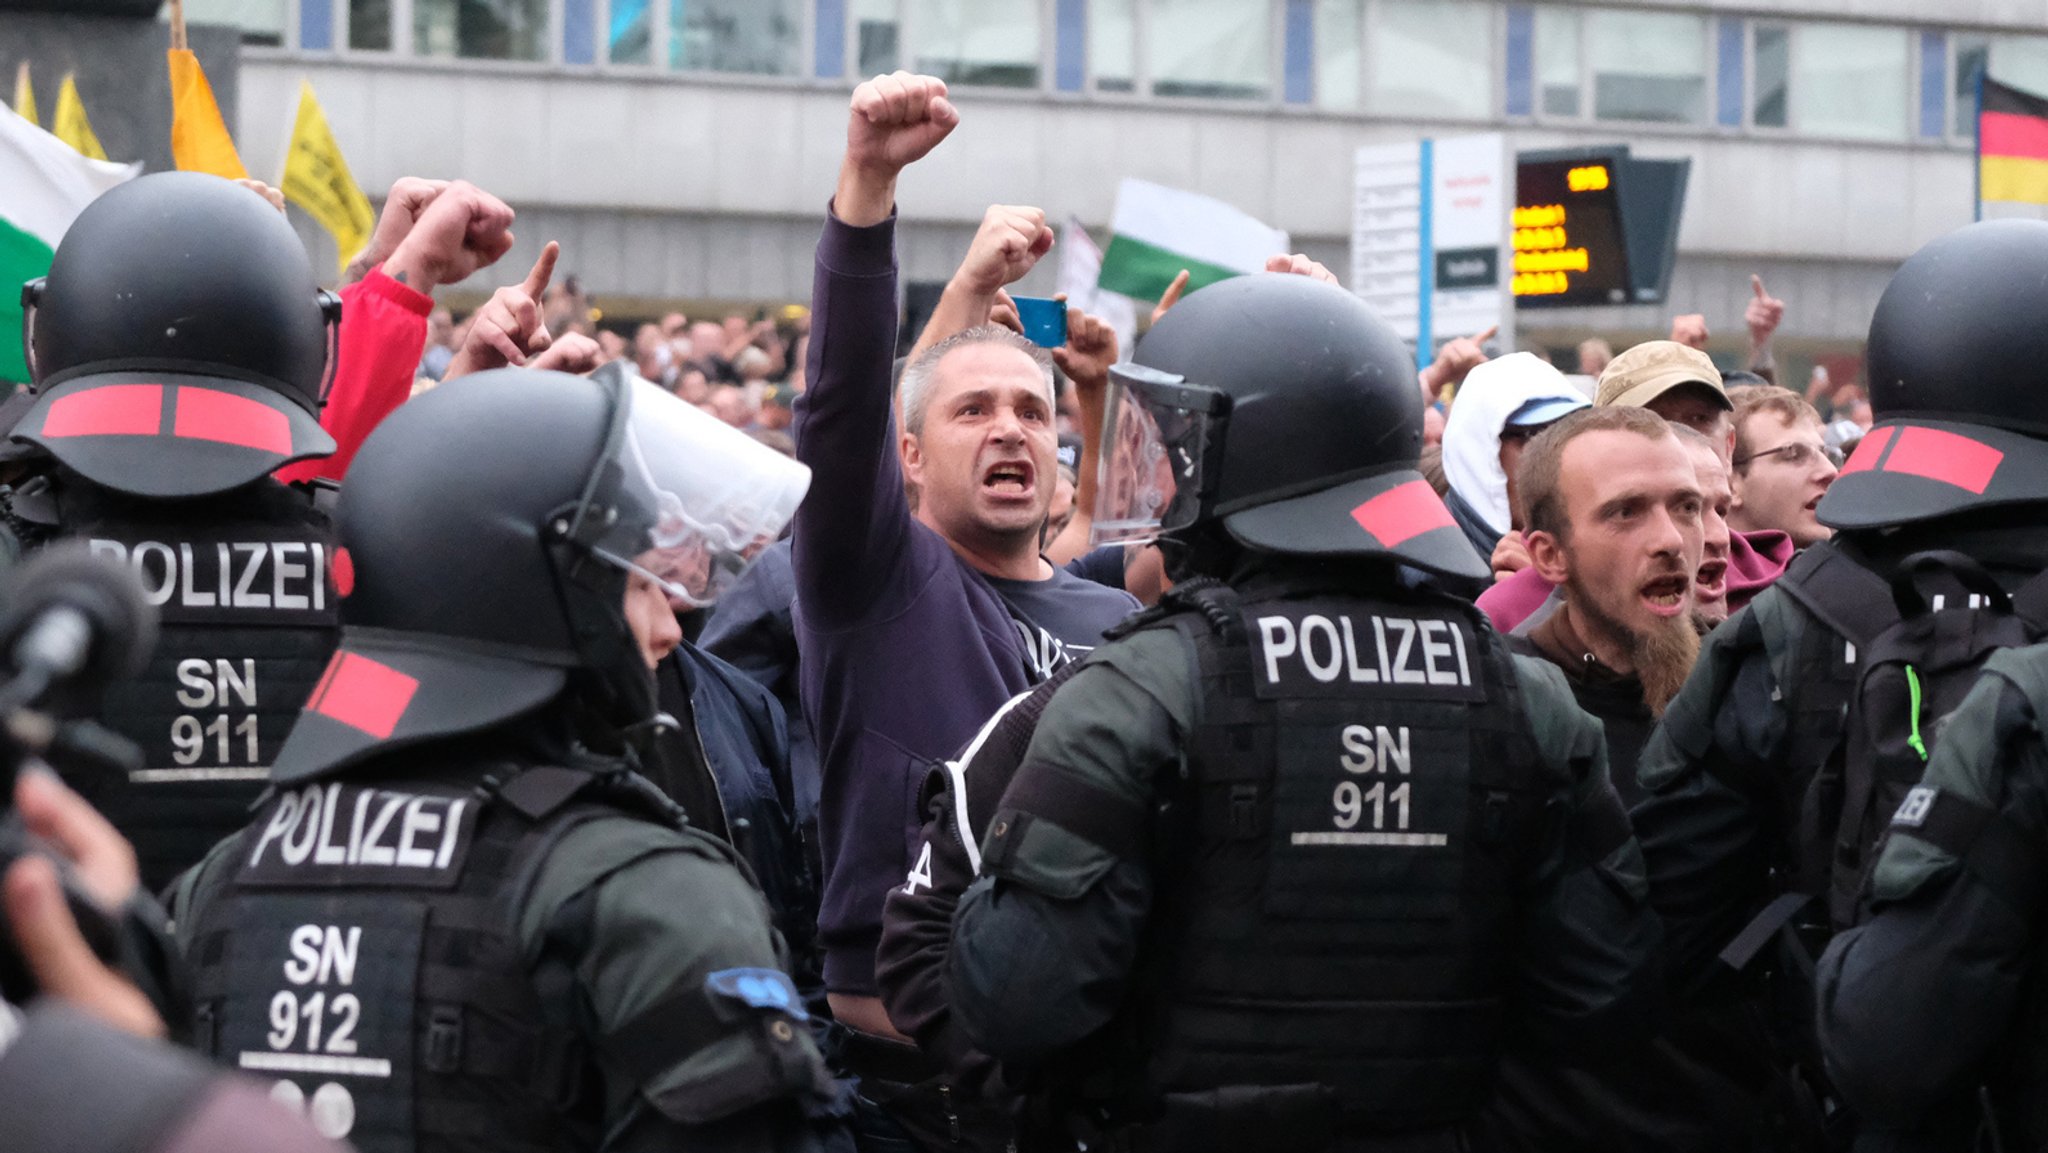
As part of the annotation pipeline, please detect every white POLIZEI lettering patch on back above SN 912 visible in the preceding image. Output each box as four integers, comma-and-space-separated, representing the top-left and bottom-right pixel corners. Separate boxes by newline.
250, 784, 469, 870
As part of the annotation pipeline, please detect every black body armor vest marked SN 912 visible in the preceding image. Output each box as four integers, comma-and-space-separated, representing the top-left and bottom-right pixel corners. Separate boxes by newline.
186, 768, 680, 1153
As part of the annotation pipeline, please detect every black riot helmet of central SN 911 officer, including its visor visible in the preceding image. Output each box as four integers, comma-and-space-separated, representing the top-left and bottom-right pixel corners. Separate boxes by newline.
1094, 272, 1487, 578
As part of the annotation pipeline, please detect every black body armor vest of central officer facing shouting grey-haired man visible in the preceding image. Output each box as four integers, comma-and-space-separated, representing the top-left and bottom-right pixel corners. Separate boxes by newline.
1089, 590, 1565, 1149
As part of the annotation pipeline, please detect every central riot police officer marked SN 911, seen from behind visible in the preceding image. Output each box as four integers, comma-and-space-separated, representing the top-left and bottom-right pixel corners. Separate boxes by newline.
948, 274, 1657, 1151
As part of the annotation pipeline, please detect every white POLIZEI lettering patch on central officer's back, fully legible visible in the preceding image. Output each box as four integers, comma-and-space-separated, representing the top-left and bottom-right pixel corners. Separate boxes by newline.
1255, 612, 1473, 688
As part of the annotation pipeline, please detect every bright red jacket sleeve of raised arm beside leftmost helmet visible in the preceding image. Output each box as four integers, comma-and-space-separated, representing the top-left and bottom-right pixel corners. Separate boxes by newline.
276, 266, 434, 483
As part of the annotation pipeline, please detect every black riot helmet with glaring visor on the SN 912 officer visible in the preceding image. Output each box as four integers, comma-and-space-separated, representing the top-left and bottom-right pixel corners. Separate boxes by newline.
272, 362, 809, 782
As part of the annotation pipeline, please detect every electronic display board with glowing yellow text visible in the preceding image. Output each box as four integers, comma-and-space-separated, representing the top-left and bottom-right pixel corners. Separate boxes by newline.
1511, 150, 1634, 307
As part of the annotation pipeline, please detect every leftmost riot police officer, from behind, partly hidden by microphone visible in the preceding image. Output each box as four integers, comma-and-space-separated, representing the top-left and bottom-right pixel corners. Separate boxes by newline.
0, 172, 340, 891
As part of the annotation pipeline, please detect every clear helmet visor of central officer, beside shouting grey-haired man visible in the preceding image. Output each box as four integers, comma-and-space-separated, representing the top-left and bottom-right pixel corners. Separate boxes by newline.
1090, 365, 1231, 545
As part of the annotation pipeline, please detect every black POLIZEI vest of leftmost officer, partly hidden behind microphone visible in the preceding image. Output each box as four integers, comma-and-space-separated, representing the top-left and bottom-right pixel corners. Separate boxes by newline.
28, 479, 348, 891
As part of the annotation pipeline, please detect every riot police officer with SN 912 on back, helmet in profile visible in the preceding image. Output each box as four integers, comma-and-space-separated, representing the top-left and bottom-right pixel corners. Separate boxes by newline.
174, 369, 851, 1153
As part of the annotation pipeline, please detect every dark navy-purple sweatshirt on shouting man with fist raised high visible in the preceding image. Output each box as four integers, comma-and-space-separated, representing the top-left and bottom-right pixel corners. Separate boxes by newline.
793, 207, 1137, 995
